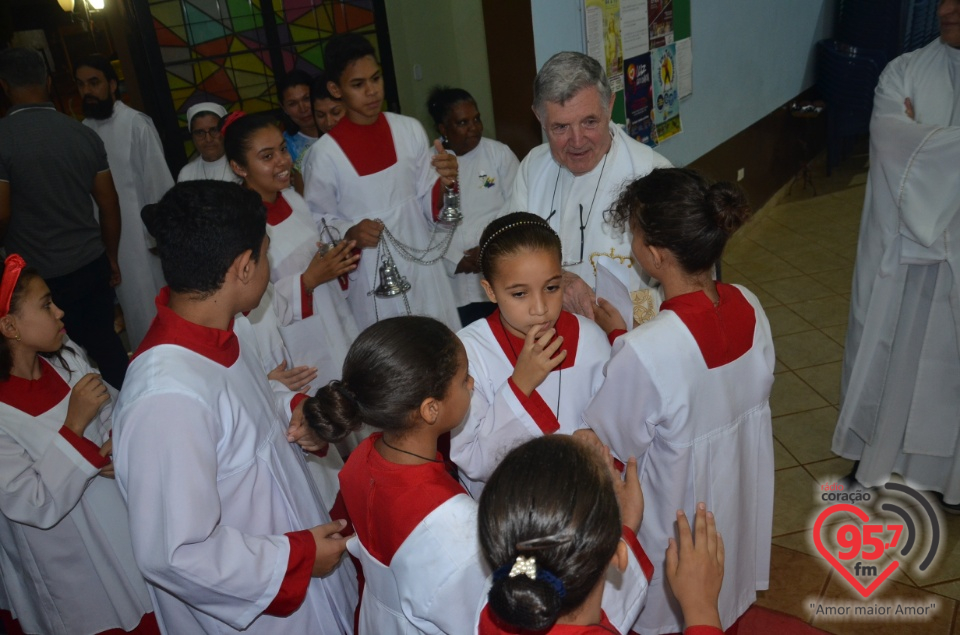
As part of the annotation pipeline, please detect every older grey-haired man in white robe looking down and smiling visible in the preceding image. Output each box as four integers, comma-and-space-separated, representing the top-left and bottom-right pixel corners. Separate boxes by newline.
507, 52, 670, 318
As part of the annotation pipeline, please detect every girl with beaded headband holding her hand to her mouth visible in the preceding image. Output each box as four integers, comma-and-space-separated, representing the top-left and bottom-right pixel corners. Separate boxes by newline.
450, 212, 610, 498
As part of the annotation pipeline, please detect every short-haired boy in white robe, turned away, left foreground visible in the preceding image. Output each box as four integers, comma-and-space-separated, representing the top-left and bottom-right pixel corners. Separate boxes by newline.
113, 181, 357, 634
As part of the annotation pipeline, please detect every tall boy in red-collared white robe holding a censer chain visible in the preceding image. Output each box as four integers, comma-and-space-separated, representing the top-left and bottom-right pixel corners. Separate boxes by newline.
303, 33, 460, 329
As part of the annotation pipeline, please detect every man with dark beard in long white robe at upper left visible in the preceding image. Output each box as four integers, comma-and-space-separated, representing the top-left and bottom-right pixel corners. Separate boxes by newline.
74, 55, 173, 350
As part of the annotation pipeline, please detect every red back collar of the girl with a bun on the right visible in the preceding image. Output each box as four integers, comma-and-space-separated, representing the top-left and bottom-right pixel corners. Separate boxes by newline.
660, 282, 757, 368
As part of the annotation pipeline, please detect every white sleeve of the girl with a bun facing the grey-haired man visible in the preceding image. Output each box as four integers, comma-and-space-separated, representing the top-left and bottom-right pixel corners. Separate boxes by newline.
583, 335, 660, 462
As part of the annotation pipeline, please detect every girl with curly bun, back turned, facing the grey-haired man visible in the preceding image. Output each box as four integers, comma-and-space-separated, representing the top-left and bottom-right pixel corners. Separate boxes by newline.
583, 168, 774, 635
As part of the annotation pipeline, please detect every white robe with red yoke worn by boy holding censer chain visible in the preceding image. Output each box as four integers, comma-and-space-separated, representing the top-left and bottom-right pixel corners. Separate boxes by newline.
303, 112, 460, 331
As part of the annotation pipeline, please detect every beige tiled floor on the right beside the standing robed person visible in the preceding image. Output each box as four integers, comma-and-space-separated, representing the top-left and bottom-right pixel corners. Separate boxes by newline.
723, 154, 960, 635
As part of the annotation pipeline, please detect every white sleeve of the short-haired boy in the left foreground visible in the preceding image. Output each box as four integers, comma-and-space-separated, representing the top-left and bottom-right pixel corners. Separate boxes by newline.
116, 394, 290, 630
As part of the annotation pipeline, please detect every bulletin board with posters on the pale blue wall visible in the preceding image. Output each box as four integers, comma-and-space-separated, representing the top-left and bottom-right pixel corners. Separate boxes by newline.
583, 0, 693, 147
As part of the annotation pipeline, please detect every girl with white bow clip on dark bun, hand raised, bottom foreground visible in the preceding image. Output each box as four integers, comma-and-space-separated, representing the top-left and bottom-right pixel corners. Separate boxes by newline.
477, 435, 724, 635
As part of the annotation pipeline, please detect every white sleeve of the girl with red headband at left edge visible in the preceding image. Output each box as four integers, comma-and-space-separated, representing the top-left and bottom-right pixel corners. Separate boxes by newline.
0, 431, 100, 529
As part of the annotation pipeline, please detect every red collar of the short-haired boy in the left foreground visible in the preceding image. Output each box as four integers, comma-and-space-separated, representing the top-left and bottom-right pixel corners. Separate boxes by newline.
133, 287, 240, 368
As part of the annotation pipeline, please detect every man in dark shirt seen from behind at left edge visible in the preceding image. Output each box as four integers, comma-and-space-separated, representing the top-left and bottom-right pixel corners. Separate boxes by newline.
0, 49, 127, 389
